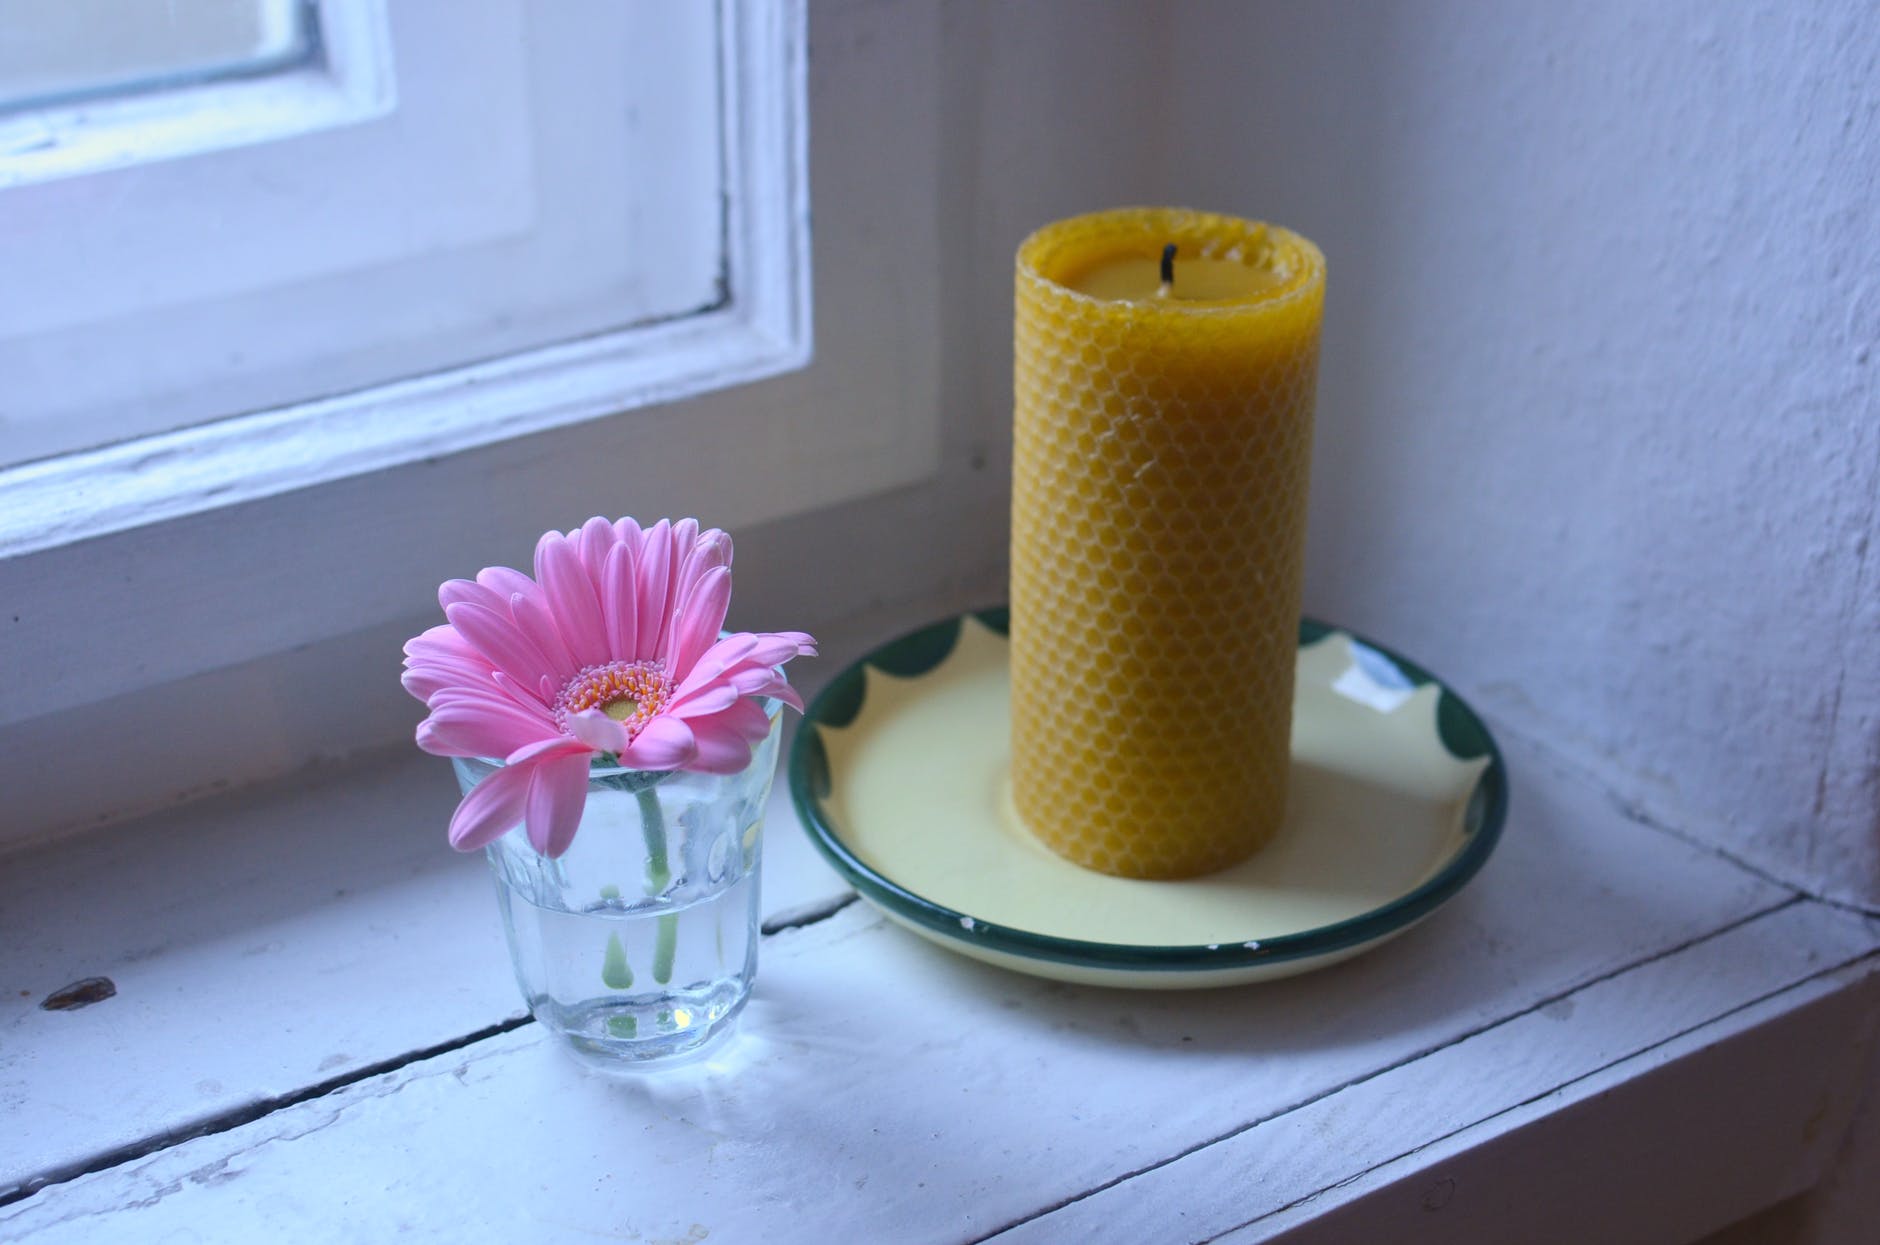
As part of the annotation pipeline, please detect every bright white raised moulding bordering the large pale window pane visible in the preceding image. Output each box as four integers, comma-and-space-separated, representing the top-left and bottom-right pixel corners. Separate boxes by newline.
0, 0, 793, 557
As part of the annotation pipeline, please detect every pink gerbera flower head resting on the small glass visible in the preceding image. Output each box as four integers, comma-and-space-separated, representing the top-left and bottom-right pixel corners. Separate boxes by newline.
404, 517, 816, 856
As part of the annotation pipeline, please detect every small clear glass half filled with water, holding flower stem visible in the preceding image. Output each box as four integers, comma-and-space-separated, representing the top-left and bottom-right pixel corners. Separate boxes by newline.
453, 701, 782, 1070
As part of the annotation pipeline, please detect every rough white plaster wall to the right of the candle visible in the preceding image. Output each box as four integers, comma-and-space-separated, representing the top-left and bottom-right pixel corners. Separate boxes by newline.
1162, 0, 1880, 908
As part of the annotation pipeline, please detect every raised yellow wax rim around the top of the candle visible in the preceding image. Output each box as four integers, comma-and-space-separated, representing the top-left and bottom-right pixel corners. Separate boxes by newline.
1017, 207, 1325, 316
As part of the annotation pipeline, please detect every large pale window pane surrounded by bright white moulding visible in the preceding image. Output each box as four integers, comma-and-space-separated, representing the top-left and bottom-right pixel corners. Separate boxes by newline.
0, 0, 733, 473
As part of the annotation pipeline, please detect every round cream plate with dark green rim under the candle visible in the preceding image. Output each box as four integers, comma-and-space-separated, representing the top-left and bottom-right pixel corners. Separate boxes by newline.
790, 611, 1508, 989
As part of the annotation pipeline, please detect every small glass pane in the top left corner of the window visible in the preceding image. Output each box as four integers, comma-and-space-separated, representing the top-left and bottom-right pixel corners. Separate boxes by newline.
0, 0, 318, 111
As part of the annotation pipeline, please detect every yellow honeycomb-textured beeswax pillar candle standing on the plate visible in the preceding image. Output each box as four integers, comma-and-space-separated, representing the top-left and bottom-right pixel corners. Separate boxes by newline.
1011, 209, 1325, 878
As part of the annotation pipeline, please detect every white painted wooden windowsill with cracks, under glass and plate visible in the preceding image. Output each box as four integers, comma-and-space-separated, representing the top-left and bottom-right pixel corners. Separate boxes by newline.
0, 609, 1880, 1241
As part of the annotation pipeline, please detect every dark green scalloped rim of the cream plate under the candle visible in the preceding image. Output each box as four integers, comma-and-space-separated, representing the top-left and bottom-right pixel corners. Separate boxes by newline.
790, 606, 1510, 974
